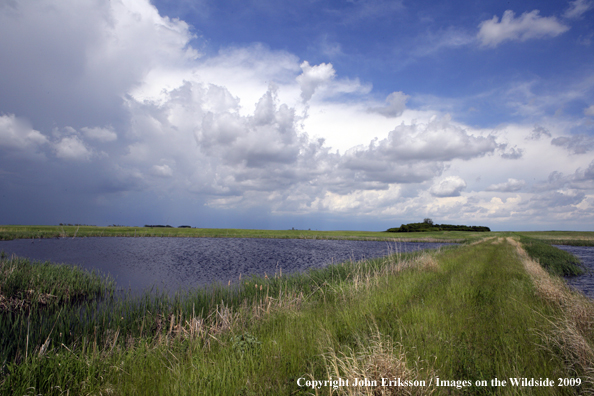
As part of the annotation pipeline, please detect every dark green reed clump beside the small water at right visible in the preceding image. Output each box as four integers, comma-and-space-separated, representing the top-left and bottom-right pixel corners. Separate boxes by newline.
520, 236, 585, 276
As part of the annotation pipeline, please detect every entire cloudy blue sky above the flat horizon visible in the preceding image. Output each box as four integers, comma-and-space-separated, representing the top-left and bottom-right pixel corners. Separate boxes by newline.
0, 0, 594, 231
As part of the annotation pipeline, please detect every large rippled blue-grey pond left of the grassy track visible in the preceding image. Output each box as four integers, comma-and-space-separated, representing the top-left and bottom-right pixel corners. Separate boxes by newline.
0, 237, 454, 292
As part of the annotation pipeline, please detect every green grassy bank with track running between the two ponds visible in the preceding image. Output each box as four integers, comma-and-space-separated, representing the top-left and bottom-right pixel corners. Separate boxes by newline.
0, 238, 594, 395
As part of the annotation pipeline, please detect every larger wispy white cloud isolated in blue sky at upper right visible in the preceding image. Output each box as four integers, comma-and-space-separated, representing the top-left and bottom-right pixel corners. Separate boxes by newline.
477, 10, 569, 47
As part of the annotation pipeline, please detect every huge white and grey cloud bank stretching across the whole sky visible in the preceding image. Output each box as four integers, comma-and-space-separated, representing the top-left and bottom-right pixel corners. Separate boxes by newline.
0, 0, 594, 229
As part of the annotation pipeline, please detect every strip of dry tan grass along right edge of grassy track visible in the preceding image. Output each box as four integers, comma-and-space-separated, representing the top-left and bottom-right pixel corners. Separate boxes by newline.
507, 238, 594, 394
